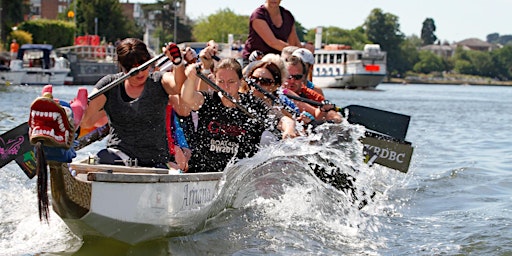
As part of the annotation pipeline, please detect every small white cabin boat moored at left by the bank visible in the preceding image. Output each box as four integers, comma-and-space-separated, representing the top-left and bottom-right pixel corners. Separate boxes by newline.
0, 44, 71, 85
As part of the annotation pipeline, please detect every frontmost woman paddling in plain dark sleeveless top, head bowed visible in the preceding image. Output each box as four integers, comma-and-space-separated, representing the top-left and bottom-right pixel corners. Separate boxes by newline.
81, 38, 186, 168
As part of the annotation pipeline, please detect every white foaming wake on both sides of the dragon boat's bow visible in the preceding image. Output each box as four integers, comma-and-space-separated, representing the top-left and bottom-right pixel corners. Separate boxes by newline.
0, 123, 408, 254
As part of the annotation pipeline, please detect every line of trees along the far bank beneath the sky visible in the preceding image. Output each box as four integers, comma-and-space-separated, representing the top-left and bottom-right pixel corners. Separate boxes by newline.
0, 0, 512, 80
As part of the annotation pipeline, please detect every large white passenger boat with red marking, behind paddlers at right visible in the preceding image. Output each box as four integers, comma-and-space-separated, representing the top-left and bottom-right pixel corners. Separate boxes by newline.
313, 44, 386, 89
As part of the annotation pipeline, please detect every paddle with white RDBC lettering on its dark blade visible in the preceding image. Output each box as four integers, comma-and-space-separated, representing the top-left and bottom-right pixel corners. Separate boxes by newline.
247, 80, 413, 173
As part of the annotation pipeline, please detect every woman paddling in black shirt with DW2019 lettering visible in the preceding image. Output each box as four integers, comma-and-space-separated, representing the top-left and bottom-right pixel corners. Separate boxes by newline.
177, 58, 296, 172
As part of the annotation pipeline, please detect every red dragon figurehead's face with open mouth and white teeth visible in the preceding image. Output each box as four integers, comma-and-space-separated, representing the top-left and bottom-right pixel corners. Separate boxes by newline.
29, 92, 74, 148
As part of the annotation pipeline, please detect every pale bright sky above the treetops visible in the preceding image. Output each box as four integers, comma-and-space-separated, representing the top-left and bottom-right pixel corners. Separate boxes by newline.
133, 0, 512, 43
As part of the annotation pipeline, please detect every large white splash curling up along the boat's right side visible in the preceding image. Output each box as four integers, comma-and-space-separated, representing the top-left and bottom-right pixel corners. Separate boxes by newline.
180, 125, 400, 254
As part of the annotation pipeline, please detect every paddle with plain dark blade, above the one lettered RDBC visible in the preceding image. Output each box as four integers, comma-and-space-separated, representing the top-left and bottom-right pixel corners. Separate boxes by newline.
286, 93, 411, 142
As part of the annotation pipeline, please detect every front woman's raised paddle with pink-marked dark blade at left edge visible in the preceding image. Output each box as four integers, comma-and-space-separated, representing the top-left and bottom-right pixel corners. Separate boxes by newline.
0, 53, 165, 176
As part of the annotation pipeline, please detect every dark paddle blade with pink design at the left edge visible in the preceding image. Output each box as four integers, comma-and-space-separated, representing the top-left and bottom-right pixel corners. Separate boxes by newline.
0, 122, 33, 168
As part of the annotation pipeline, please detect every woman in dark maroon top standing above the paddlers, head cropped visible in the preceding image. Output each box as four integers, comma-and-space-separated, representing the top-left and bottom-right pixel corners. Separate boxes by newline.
242, 0, 301, 66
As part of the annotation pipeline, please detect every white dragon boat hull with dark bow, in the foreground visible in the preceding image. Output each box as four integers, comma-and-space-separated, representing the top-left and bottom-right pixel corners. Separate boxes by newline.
50, 161, 222, 244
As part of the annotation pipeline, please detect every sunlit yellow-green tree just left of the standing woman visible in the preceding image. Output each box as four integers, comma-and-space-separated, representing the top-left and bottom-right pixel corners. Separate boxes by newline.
192, 9, 249, 43
